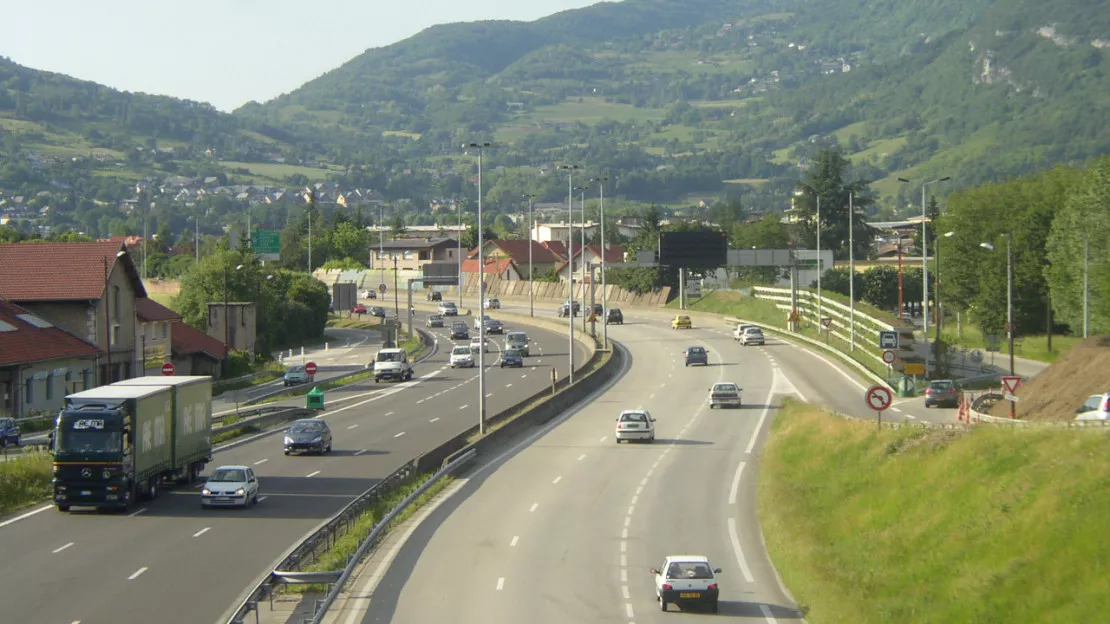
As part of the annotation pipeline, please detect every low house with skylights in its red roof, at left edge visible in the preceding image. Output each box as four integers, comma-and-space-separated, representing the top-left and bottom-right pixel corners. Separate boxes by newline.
0, 300, 101, 417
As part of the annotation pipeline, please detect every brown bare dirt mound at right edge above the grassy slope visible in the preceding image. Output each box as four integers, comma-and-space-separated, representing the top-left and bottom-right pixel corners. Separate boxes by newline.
989, 335, 1110, 421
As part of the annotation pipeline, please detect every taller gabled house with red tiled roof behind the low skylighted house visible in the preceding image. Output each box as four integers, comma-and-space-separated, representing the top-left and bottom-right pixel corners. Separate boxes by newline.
0, 241, 147, 385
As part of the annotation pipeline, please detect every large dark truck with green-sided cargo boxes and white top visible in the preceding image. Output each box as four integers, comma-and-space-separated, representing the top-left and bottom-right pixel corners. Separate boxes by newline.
52, 376, 212, 512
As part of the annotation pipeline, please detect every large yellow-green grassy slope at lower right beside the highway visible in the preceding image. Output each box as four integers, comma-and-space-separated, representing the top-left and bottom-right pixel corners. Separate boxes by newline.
758, 403, 1110, 624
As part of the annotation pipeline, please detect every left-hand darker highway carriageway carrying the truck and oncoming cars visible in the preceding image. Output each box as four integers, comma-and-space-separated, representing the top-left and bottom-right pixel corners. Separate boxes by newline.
0, 314, 585, 624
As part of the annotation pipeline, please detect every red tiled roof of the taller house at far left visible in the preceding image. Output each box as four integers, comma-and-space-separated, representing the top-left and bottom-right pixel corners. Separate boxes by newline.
0, 241, 147, 302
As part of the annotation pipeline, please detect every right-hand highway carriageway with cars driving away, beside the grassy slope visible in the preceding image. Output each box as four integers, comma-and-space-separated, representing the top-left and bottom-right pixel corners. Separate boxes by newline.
327, 306, 950, 624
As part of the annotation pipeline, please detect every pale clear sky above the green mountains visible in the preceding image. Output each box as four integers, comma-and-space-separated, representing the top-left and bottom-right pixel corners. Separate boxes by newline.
0, 0, 597, 112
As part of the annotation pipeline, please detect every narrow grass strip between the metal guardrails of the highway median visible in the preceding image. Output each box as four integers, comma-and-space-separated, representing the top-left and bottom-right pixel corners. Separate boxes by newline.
289, 473, 454, 593
